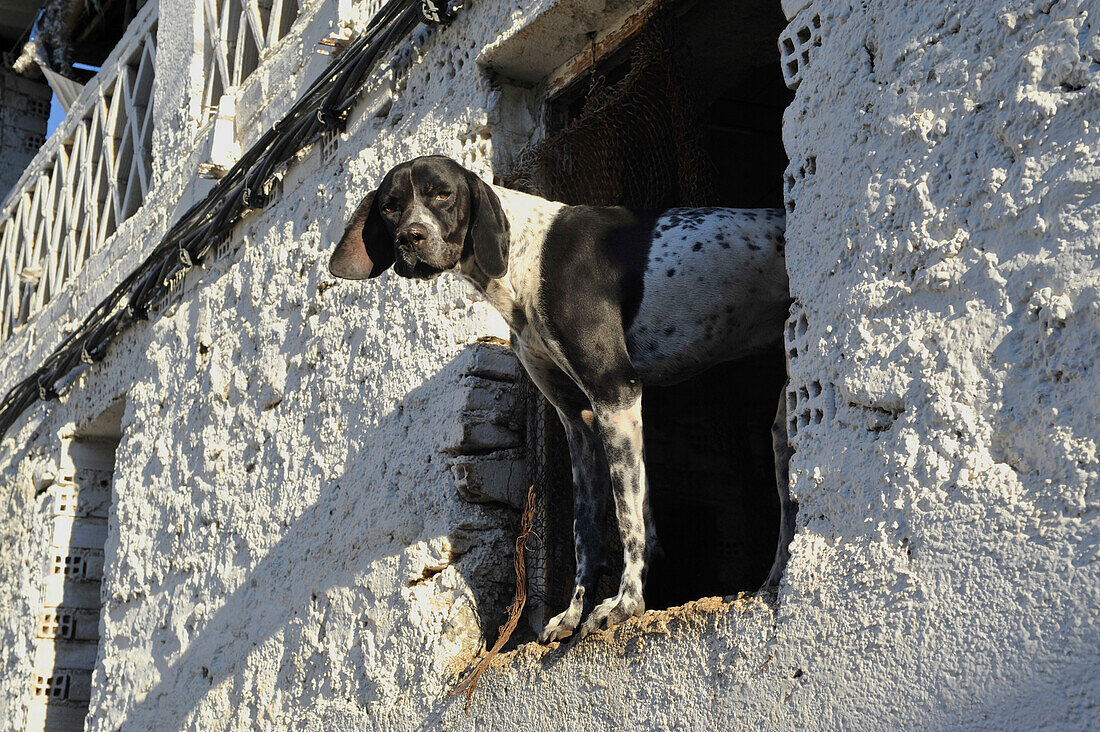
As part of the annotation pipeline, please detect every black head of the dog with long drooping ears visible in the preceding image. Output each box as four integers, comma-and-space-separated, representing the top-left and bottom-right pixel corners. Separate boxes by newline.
329, 155, 509, 280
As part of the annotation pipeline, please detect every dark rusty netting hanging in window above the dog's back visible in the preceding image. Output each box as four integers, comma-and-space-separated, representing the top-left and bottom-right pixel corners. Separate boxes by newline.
505, 8, 716, 208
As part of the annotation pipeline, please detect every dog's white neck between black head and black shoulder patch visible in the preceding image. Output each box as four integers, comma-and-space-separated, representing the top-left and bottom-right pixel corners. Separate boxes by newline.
460, 186, 565, 332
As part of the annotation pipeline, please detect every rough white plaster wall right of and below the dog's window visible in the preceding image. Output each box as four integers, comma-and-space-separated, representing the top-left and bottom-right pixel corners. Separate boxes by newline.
451, 1, 1100, 729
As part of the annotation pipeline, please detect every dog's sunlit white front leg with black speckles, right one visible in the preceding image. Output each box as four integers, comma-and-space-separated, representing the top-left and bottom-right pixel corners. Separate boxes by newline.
583, 385, 656, 634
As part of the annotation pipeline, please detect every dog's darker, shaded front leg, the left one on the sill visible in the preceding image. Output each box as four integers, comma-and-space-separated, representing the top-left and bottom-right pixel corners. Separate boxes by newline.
539, 408, 607, 643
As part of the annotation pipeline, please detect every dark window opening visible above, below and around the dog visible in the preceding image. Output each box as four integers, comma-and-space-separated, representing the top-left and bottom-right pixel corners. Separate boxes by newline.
505, 0, 793, 626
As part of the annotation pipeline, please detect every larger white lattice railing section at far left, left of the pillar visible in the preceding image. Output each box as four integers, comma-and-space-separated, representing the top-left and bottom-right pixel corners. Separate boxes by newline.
0, 2, 157, 341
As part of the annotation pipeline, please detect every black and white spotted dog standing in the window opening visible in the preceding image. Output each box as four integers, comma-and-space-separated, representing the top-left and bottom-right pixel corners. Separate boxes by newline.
329, 156, 794, 642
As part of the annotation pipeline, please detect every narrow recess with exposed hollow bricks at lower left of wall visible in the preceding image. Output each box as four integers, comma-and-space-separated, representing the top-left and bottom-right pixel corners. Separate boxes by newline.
26, 402, 122, 732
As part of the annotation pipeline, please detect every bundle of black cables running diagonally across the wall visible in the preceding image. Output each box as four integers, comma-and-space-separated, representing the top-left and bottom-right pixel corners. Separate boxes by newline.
0, 0, 462, 436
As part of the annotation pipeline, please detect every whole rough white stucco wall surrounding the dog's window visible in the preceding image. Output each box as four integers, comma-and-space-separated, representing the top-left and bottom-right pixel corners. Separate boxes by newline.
0, 0, 1100, 730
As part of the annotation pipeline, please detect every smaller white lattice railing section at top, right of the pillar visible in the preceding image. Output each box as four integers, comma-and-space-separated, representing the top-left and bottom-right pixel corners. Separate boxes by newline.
202, 0, 298, 120
